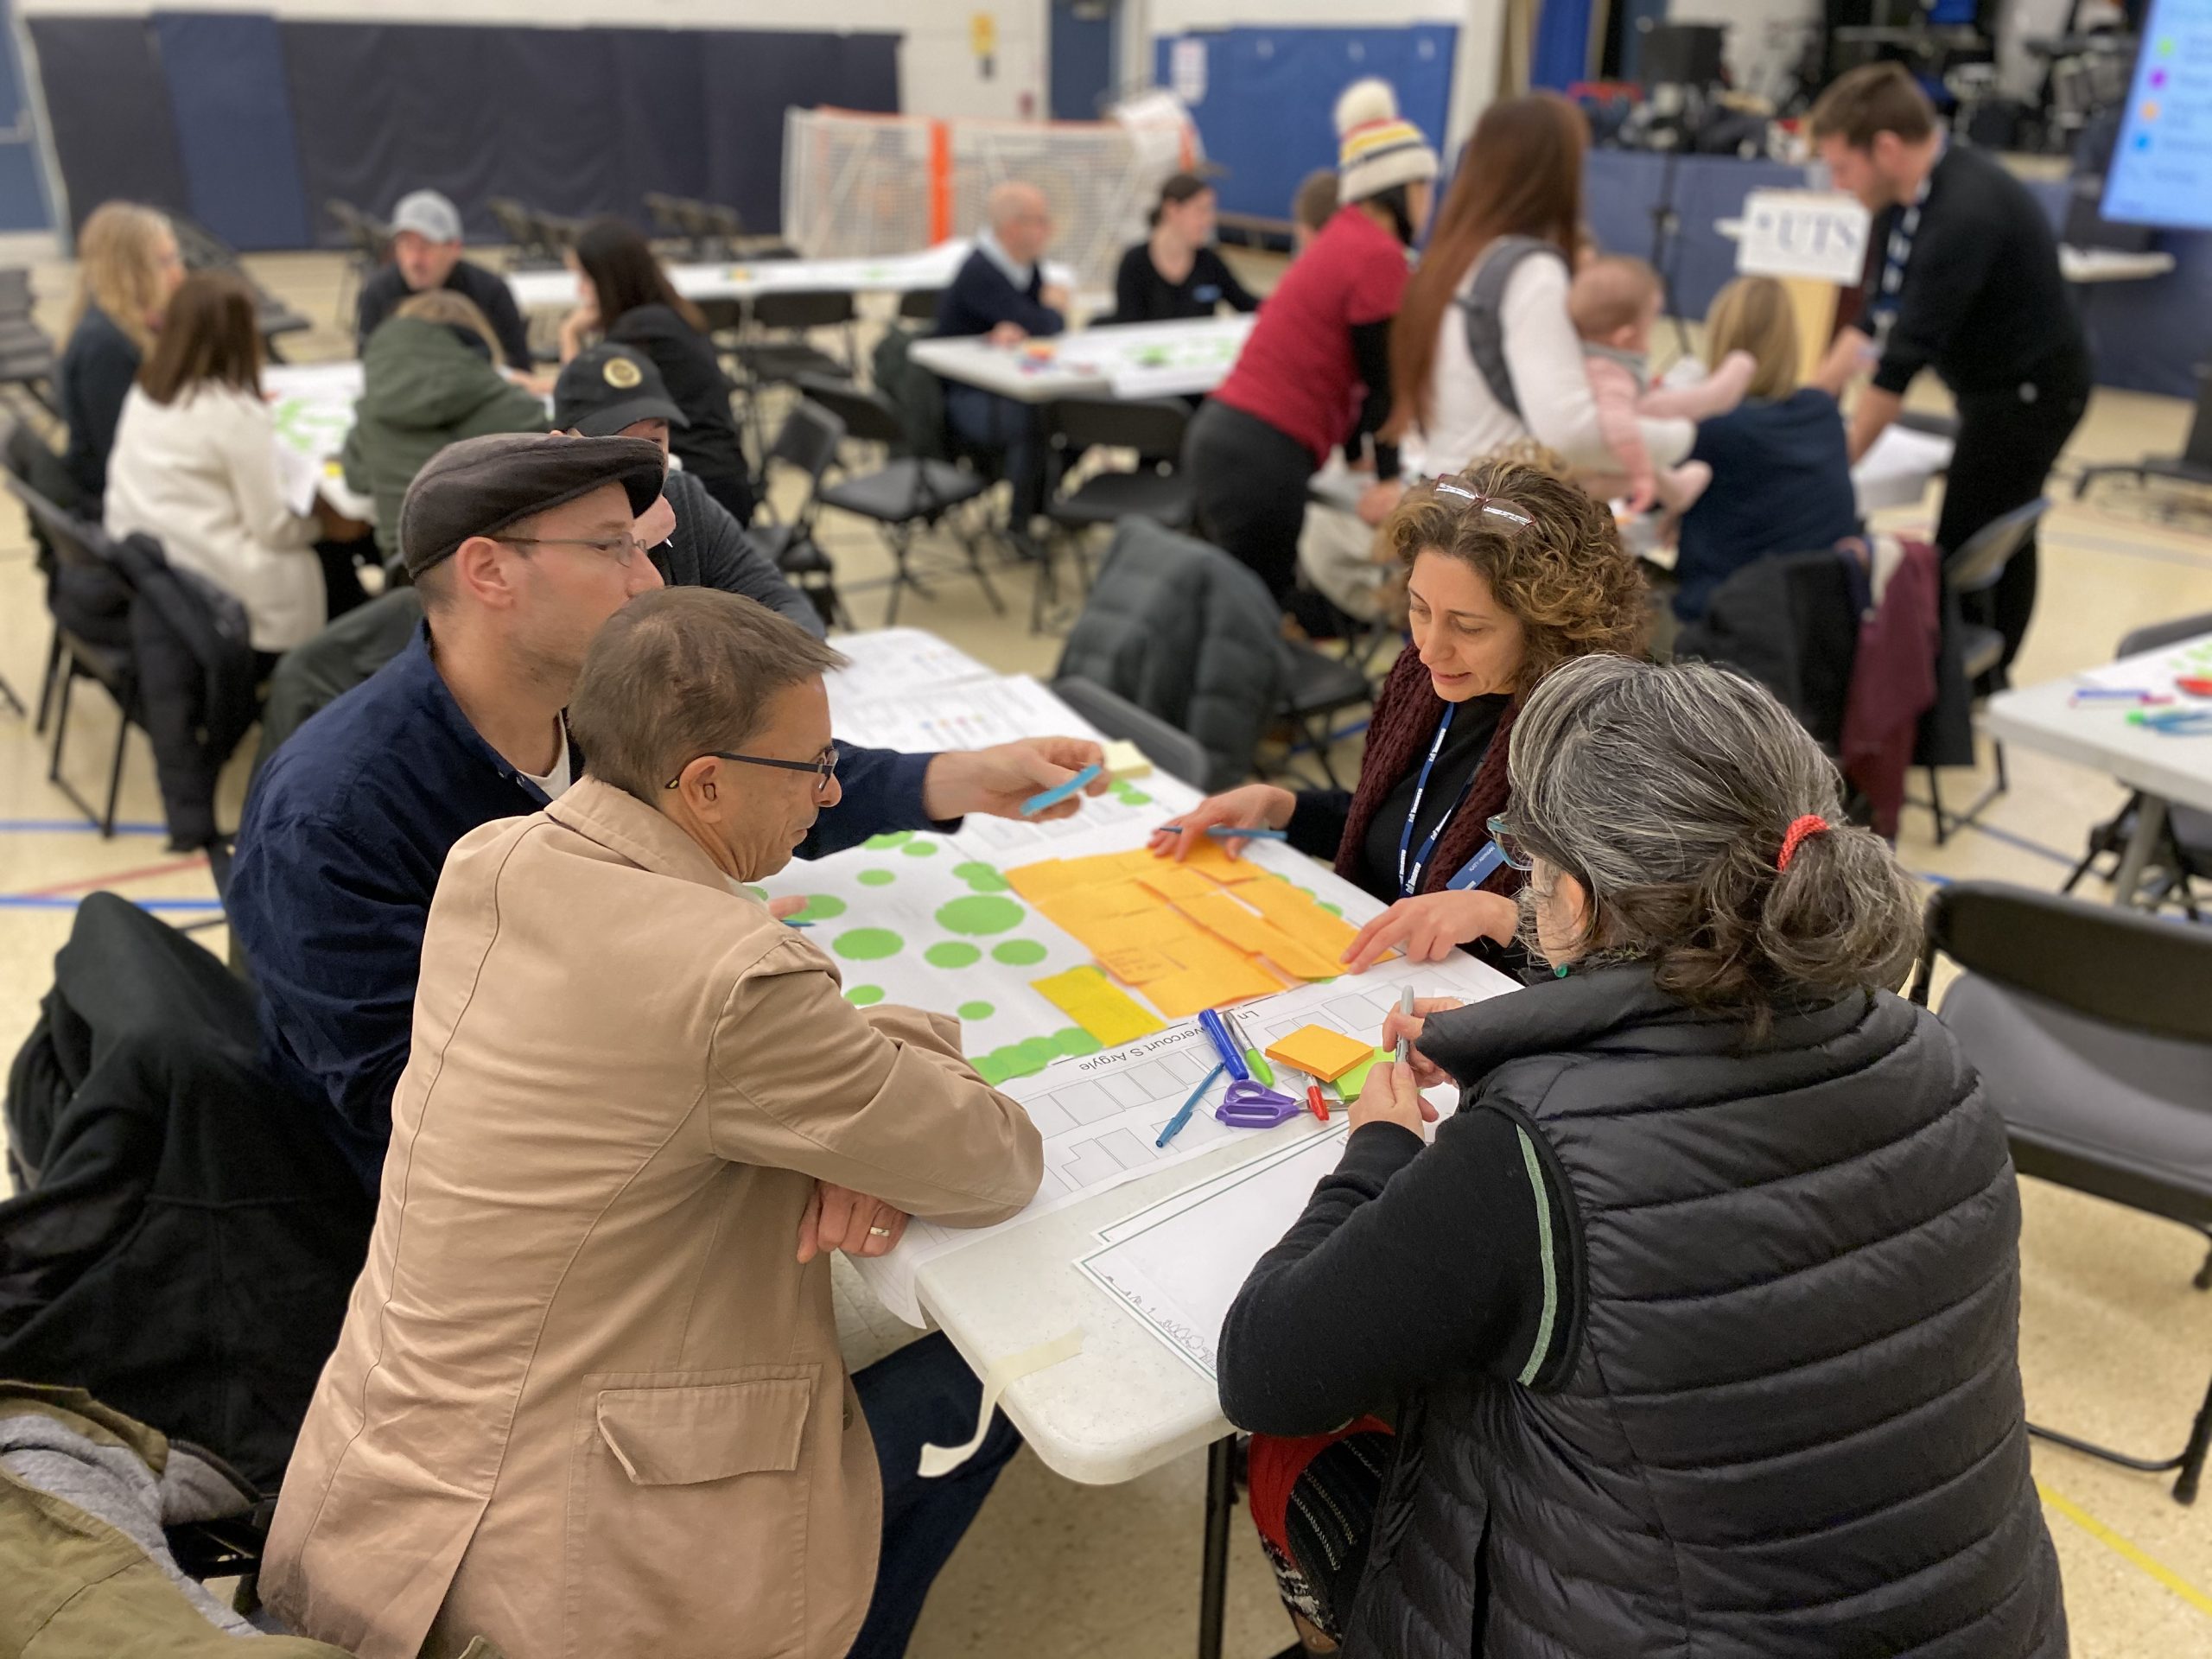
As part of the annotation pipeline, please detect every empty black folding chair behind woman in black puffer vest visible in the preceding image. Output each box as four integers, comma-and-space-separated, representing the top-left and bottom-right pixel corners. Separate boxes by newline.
1911, 882, 2212, 1504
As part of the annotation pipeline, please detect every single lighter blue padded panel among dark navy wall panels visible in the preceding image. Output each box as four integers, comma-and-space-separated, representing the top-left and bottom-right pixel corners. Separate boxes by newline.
153, 11, 309, 248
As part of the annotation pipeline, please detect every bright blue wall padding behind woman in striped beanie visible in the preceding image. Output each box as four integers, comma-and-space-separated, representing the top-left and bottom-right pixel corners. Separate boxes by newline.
1153, 22, 1460, 219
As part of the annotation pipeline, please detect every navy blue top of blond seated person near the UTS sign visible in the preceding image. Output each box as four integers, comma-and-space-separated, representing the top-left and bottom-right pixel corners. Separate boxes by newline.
1675, 387, 1858, 621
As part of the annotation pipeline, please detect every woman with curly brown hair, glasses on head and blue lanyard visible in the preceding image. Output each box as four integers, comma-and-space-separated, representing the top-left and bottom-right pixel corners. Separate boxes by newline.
1153, 460, 1646, 973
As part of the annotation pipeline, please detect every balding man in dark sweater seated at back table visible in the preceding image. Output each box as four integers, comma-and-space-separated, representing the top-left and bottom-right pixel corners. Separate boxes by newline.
938, 181, 1068, 533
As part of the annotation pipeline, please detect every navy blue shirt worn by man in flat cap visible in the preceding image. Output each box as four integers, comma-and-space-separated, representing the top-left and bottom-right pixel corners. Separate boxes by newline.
226, 626, 957, 1192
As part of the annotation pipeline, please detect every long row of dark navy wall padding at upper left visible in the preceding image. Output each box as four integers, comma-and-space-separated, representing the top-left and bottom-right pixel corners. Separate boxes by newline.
31, 11, 900, 250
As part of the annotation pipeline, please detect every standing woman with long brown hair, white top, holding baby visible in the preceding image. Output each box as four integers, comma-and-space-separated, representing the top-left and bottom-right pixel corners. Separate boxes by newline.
1391, 93, 1697, 478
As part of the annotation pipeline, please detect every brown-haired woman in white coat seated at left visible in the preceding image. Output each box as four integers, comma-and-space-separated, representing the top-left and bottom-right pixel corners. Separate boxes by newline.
104, 270, 365, 652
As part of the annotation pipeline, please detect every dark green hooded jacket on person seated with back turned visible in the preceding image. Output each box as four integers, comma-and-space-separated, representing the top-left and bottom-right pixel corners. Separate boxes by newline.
339, 316, 553, 562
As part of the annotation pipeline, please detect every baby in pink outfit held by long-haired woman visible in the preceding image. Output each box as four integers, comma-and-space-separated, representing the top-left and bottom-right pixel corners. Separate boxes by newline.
1566, 254, 1758, 518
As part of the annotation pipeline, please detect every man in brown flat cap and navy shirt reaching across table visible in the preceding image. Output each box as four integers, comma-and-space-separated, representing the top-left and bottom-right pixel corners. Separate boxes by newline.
226, 434, 1103, 1190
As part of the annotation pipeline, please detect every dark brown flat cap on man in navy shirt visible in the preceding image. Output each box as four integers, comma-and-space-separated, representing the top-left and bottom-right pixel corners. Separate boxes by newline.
400, 431, 664, 577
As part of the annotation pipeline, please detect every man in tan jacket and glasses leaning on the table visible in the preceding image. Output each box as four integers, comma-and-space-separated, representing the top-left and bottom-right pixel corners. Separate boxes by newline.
261, 588, 1042, 1659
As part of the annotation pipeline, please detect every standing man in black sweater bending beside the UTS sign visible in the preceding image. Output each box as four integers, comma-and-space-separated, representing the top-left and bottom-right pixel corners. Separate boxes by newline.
1812, 64, 2093, 677
